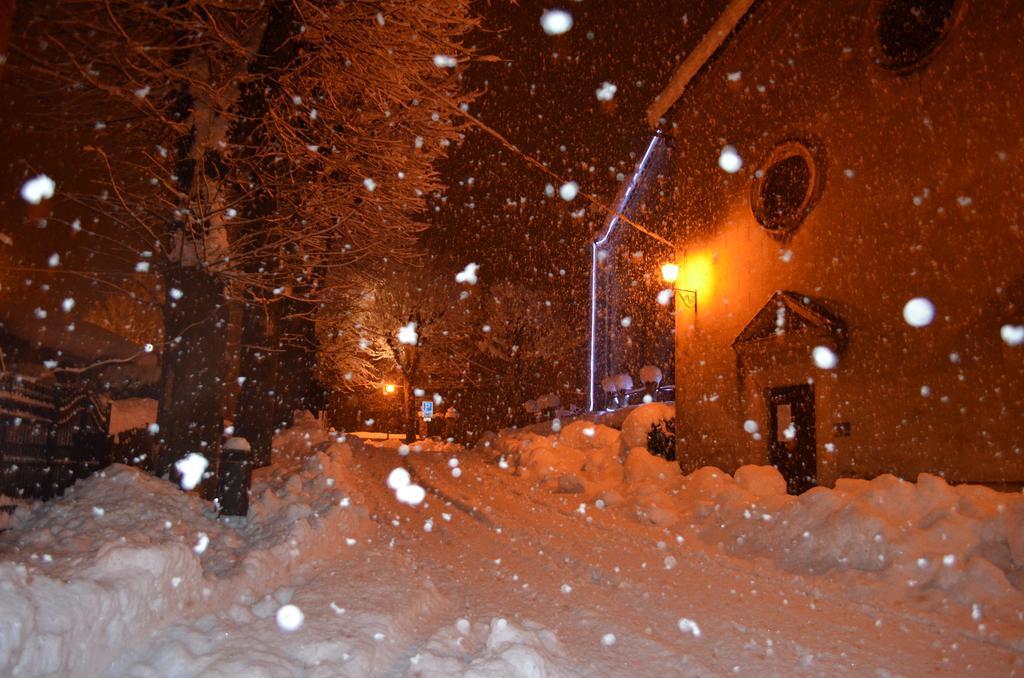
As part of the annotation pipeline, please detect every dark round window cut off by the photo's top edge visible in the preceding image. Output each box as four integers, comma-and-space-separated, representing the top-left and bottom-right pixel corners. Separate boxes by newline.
876, 0, 959, 71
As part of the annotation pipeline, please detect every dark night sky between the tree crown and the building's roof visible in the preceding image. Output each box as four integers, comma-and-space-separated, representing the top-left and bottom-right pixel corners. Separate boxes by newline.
428, 0, 724, 288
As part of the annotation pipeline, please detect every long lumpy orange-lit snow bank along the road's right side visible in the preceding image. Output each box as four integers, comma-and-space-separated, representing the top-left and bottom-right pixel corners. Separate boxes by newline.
478, 428, 1024, 609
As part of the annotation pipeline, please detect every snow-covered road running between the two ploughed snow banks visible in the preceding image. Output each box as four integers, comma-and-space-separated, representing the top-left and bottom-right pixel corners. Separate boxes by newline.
108, 446, 1024, 676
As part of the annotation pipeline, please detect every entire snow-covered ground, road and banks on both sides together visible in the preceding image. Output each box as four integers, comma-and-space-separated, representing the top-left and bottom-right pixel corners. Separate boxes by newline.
0, 411, 1024, 676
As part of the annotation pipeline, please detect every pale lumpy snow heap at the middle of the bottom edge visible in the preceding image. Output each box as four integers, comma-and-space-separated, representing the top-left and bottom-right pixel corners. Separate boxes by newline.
409, 618, 580, 678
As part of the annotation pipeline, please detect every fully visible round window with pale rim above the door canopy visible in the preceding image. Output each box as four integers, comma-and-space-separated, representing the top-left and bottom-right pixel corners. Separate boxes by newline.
751, 141, 821, 234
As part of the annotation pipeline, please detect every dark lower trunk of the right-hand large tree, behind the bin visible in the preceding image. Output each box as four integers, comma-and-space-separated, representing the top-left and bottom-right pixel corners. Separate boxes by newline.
234, 302, 281, 468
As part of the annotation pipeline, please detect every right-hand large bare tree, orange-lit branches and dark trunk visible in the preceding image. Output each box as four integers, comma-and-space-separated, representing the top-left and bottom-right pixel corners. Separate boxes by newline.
234, 0, 474, 463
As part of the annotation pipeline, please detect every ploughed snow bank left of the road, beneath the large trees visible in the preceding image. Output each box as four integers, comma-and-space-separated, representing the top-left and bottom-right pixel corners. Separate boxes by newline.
0, 417, 369, 675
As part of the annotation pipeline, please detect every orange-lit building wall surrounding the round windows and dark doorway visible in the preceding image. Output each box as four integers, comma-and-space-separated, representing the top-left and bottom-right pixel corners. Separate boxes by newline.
651, 0, 1024, 485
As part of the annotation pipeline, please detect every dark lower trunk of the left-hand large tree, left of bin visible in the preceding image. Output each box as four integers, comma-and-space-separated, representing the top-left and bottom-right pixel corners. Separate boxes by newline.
157, 267, 227, 499
